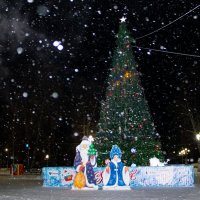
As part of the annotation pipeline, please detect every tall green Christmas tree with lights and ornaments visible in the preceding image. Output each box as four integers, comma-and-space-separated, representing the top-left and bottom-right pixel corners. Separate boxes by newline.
95, 22, 162, 165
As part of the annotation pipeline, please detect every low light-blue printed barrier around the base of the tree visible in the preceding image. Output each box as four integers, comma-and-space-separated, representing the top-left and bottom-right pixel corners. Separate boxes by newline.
42, 165, 194, 190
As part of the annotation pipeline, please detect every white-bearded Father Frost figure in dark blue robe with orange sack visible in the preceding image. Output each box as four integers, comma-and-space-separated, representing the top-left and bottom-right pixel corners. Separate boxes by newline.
73, 136, 98, 189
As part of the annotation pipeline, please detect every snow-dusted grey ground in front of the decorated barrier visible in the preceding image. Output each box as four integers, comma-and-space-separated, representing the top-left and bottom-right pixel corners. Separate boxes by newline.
0, 175, 200, 200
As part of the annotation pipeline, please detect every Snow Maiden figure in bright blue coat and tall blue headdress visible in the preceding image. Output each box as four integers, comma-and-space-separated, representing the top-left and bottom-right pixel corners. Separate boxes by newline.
103, 145, 130, 190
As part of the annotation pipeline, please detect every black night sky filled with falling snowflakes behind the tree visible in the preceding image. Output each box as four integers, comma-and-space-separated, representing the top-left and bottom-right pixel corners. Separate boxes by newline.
0, 0, 200, 167
